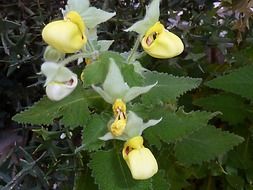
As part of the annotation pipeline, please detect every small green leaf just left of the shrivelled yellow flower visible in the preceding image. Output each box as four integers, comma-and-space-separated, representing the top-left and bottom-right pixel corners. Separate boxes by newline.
83, 115, 109, 151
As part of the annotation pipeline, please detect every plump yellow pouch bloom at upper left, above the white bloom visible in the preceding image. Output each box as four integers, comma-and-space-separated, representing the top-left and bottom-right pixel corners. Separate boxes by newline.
42, 11, 87, 53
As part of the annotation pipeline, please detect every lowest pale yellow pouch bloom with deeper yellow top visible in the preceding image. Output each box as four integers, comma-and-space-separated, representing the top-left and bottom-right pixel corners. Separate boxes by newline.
122, 136, 158, 180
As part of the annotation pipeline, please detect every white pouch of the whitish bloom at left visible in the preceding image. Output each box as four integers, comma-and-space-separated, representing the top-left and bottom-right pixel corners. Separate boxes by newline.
46, 74, 78, 101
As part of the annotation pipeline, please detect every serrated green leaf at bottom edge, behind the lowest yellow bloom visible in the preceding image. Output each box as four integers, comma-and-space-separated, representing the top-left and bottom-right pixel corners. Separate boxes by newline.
89, 150, 151, 190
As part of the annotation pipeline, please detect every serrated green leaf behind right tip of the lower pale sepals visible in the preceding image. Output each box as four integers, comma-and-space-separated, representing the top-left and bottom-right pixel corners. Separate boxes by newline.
144, 108, 217, 148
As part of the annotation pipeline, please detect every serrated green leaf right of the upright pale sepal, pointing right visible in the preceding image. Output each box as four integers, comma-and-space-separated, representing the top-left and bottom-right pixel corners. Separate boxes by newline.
143, 72, 201, 104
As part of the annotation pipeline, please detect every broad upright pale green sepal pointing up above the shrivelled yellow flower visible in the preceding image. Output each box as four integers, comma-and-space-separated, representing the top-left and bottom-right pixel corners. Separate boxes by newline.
103, 59, 129, 99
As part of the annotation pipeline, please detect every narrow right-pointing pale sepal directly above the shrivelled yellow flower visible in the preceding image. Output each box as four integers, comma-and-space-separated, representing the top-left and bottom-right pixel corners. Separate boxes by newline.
123, 82, 157, 102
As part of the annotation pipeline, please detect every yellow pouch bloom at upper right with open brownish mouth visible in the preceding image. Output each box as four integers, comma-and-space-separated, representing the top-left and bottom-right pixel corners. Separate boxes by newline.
141, 22, 184, 59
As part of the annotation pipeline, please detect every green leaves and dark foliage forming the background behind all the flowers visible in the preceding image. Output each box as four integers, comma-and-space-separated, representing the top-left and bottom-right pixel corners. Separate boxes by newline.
0, 0, 253, 190
